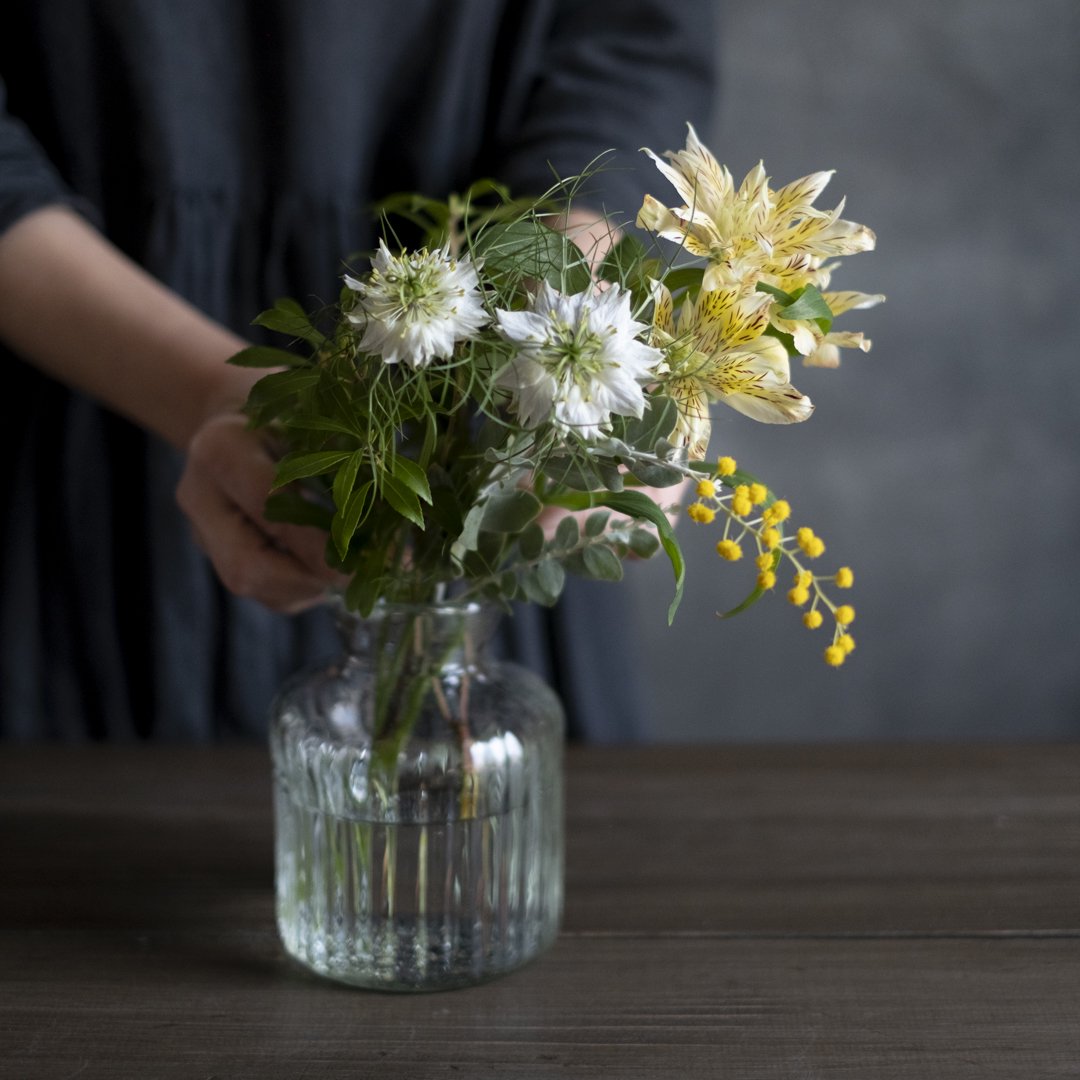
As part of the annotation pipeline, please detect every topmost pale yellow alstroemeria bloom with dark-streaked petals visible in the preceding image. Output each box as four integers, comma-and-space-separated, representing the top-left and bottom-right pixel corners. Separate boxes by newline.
637, 125, 875, 291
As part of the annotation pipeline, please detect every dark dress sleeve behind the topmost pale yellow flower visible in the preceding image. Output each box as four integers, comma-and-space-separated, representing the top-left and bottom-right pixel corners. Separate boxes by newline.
492, 0, 719, 220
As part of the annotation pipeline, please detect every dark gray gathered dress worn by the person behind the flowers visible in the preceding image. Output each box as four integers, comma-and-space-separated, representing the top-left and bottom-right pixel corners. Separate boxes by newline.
0, 0, 716, 740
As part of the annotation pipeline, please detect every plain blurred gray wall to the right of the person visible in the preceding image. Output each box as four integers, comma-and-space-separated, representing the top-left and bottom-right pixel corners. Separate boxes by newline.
623, 0, 1080, 740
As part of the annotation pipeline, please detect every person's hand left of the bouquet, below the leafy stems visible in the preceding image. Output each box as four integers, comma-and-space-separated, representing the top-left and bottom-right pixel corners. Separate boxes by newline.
176, 414, 346, 613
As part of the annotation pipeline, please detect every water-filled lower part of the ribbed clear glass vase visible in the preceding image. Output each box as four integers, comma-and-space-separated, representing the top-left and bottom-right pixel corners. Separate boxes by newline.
276, 778, 563, 991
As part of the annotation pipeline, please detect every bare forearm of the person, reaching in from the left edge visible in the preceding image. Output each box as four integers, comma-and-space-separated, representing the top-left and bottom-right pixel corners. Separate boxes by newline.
0, 206, 253, 448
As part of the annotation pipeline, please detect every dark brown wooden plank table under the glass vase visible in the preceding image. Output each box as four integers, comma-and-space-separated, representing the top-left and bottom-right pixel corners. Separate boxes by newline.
0, 746, 1080, 1080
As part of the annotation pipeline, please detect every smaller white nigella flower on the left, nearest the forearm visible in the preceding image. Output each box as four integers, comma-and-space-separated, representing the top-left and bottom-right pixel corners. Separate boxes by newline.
345, 241, 489, 367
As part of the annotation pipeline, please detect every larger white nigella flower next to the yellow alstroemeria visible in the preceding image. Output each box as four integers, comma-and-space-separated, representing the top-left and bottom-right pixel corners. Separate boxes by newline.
496, 282, 663, 438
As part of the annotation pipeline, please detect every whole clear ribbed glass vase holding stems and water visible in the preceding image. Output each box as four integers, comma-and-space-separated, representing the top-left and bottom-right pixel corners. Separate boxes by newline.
271, 604, 564, 990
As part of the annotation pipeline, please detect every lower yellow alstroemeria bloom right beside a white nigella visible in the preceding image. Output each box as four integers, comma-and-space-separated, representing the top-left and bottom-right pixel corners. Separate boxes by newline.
652, 283, 813, 460
